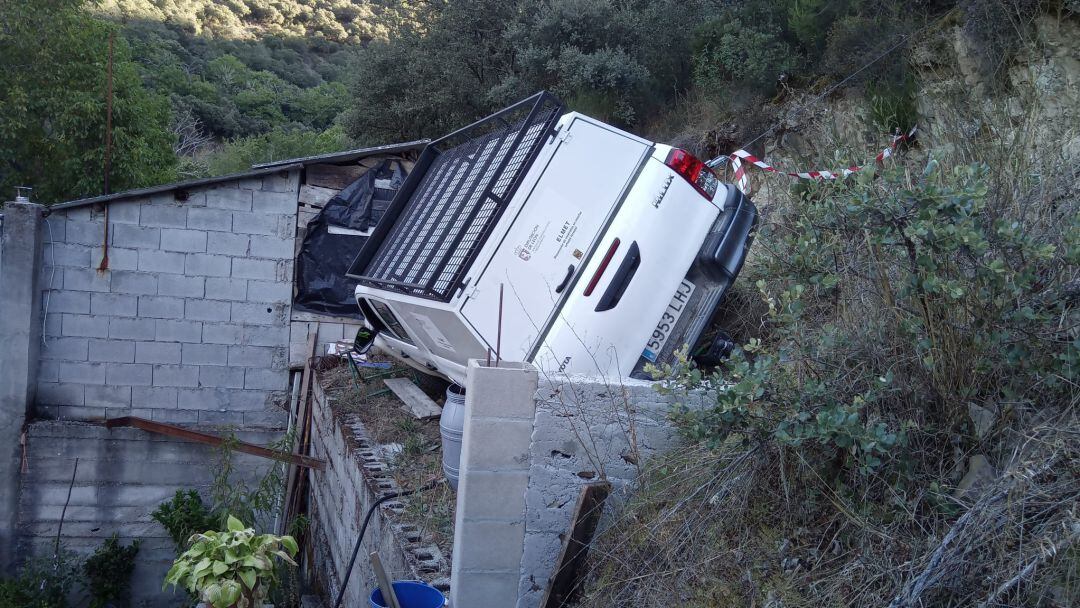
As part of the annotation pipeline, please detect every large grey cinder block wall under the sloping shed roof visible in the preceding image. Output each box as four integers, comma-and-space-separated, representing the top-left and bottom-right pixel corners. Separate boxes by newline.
37, 171, 299, 428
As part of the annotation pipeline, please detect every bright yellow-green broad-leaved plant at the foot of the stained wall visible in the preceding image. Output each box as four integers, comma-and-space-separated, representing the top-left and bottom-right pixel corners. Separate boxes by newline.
162, 515, 297, 608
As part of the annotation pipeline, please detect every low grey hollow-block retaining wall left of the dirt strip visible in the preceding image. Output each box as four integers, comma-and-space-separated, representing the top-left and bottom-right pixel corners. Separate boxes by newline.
309, 373, 449, 606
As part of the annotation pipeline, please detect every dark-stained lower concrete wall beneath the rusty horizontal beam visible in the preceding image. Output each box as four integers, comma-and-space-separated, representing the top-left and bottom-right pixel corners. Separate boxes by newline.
13, 420, 278, 606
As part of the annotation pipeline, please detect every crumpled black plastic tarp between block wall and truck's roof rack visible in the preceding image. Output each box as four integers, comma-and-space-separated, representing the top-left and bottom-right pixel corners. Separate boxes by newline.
293, 160, 406, 319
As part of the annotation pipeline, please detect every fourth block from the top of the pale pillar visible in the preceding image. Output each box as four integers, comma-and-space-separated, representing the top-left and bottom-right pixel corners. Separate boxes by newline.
454, 519, 525, 570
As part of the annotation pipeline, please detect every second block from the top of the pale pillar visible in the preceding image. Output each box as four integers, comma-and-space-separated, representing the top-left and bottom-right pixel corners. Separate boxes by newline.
461, 421, 532, 471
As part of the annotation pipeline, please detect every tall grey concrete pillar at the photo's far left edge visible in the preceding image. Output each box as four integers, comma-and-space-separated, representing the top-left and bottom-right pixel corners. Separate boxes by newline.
0, 203, 44, 572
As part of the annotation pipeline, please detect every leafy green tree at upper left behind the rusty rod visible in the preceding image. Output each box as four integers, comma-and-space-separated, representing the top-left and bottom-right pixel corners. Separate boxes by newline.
0, 0, 176, 203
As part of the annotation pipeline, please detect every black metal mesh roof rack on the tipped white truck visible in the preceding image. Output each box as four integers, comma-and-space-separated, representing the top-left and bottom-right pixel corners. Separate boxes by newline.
347, 93, 564, 301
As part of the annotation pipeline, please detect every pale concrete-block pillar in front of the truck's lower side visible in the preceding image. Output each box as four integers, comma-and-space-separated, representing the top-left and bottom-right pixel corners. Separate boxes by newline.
450, 360, 538, 607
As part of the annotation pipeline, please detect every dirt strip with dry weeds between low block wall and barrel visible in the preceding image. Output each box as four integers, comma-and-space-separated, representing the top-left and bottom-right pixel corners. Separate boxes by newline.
319, 350, 456, 548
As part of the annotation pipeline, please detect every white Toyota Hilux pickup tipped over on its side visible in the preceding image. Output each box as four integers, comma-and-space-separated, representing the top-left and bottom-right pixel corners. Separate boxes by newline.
348, 93, 757, 384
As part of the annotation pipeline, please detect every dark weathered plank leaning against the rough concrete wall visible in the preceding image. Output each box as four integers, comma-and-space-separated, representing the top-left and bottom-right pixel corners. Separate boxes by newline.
540, 482, 611, 608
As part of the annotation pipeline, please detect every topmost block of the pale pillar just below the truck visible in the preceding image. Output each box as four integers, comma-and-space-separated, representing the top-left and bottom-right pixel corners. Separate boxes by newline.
465, 360, 539, 423
